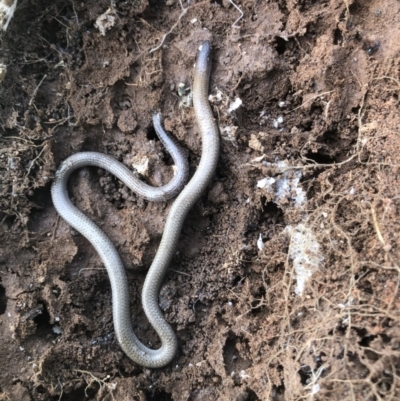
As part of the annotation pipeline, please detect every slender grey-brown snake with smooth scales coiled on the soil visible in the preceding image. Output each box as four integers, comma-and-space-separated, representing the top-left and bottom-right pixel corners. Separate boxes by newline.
51, 42, 219, 368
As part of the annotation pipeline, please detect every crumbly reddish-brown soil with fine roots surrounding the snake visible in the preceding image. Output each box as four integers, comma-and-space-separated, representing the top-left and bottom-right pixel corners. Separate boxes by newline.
0, 0, 400, 401
